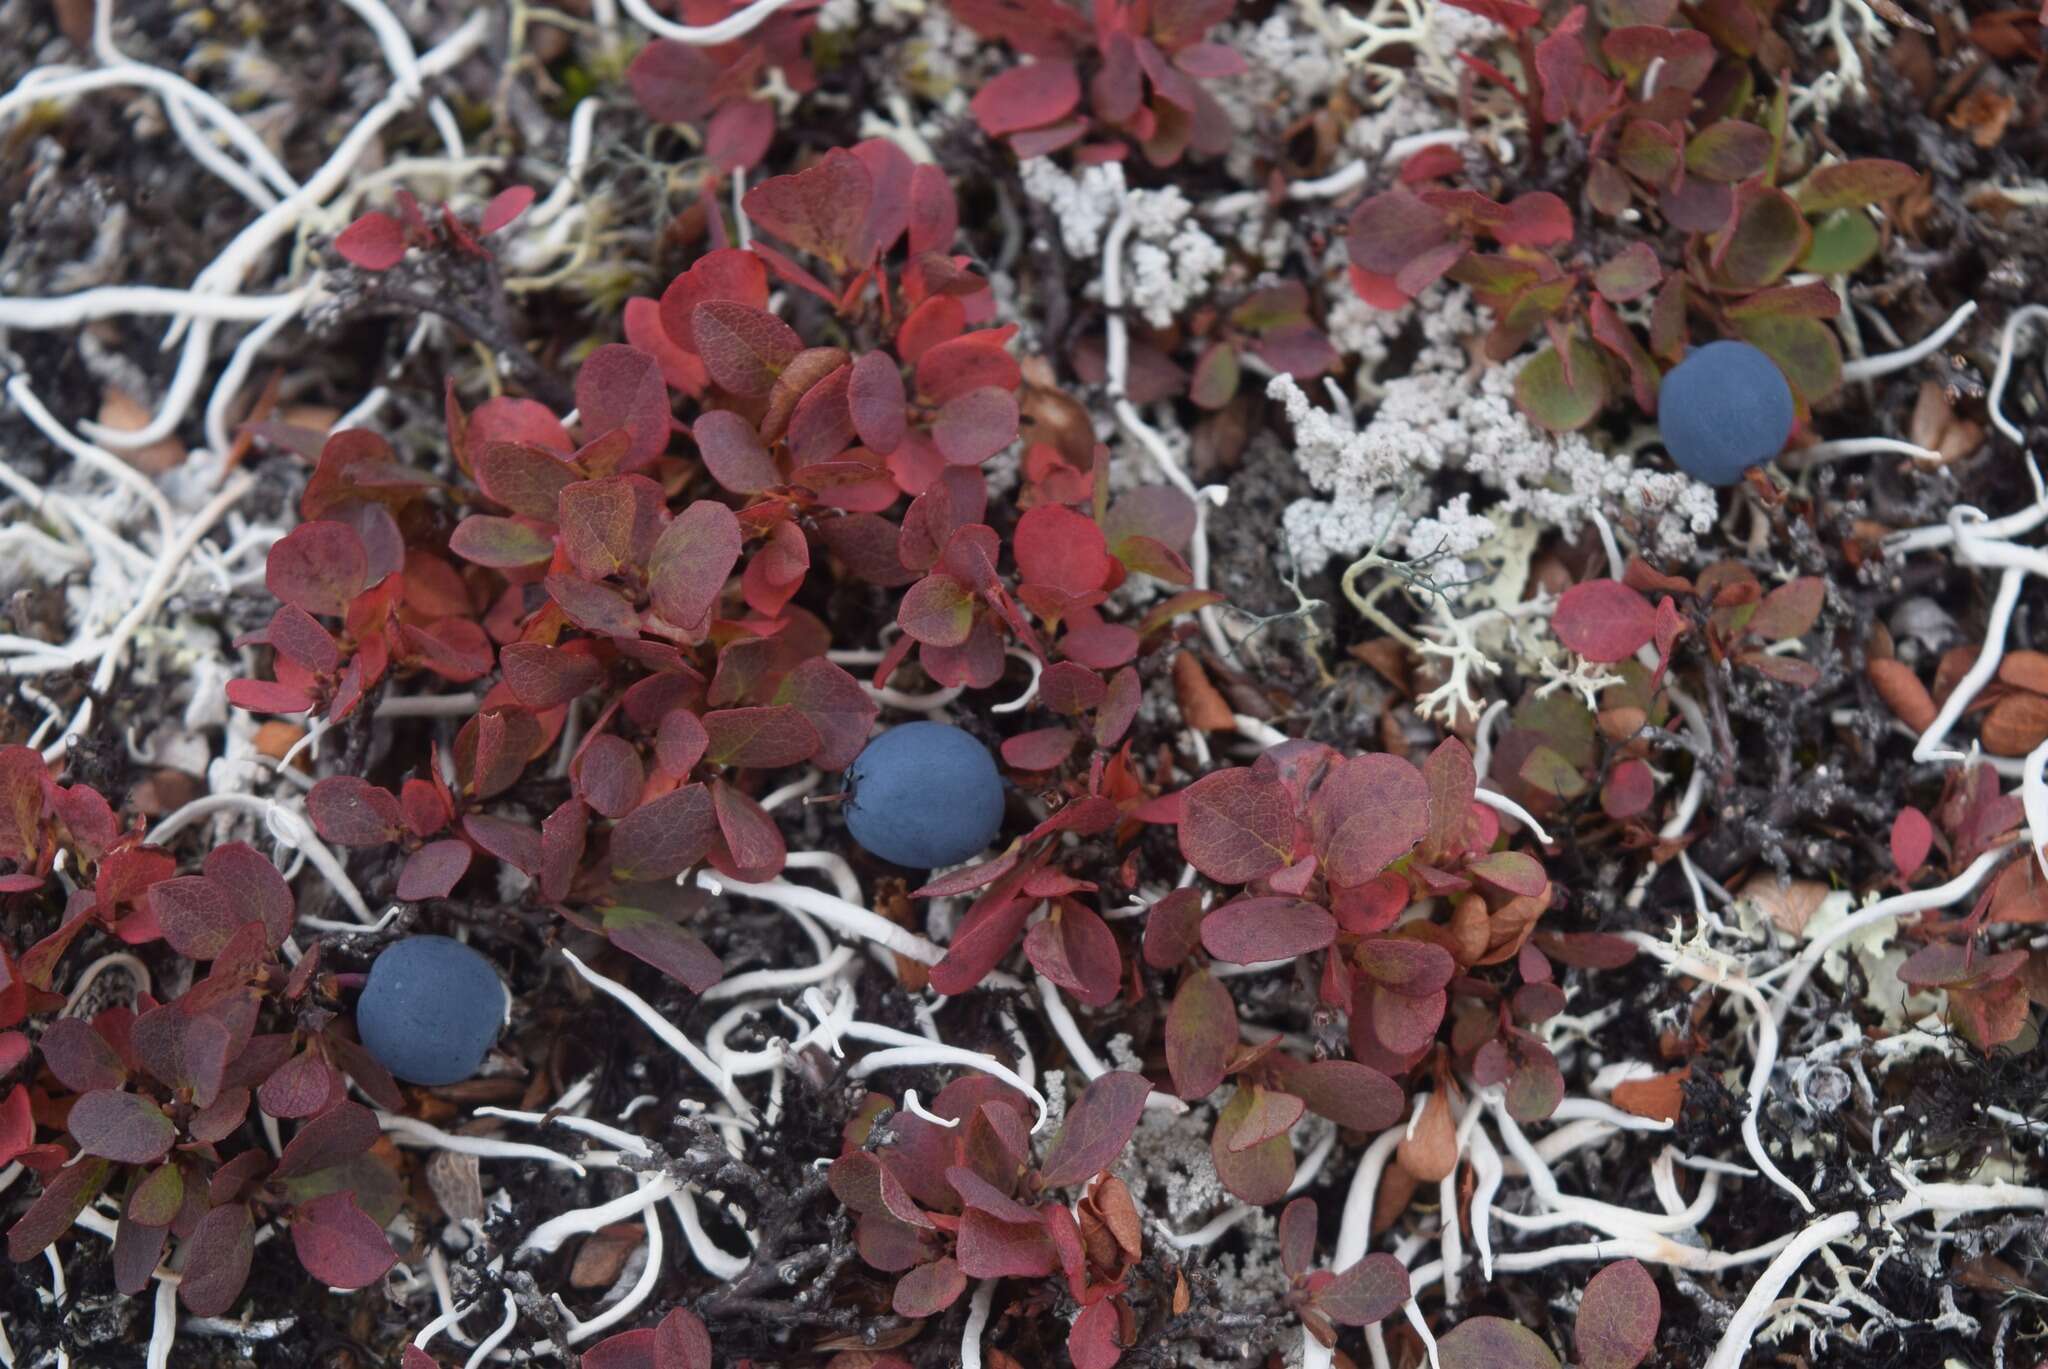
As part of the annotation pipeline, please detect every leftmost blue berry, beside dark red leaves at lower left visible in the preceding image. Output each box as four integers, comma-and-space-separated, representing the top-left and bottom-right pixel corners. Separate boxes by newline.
356, 937, 506, 1084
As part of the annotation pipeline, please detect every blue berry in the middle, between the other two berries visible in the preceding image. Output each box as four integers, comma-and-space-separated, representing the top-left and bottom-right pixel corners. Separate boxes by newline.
846, 723, 1004, 869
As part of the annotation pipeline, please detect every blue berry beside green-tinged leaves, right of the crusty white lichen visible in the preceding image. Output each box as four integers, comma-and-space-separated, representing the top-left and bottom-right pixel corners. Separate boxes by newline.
1657, 342, 1794, 486
